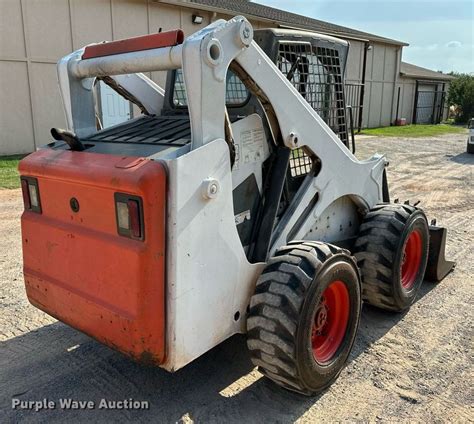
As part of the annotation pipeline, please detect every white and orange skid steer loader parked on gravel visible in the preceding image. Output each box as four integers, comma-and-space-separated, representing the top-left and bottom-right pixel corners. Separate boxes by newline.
19, 17, 453, 395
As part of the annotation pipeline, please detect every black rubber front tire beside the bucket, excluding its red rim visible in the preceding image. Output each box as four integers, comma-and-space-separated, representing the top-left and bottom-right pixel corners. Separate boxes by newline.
354, 204, 429, 312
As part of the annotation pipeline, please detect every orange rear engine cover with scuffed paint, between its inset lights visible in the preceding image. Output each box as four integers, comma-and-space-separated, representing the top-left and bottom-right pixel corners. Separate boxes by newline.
19, 149, 166, 365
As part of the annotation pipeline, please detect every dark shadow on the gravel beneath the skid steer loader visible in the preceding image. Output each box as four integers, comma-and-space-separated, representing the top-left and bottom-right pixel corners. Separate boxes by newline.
0, 283, 434, 422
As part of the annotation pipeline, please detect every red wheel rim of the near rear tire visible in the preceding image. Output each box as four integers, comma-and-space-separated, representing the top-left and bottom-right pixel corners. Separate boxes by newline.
311, 280, 350, 363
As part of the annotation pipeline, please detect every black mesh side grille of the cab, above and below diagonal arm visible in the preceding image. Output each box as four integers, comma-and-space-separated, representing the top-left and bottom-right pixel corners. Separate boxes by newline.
277, 42, 347, 176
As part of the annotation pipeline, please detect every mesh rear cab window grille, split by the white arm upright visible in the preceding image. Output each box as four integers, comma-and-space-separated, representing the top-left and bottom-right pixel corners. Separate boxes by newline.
173, 69, 250, 107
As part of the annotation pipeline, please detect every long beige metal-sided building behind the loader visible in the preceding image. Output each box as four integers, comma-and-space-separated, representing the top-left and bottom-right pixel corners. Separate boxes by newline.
0, 0, 449, 155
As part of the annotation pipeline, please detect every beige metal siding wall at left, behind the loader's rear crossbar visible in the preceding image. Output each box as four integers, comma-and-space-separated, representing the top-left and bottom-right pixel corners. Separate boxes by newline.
0, 0, 211, 155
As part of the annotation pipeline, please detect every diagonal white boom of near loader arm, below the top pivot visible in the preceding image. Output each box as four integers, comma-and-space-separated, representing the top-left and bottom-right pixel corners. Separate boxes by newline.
231, 42, 387, 254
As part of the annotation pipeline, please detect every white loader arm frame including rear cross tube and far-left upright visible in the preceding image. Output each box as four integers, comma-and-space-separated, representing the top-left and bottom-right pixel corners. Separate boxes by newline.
55, 16, 387, 254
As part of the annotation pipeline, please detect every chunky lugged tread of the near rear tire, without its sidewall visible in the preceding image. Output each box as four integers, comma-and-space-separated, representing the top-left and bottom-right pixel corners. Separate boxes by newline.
247, 241, 349, 394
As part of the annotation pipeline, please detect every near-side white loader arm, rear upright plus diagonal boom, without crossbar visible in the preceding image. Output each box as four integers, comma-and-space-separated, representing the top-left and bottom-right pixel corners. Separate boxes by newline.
174, 17, 387, 254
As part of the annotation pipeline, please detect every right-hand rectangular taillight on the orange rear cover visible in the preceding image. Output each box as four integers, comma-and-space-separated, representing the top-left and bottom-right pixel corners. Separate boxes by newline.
115, 193, 145, 240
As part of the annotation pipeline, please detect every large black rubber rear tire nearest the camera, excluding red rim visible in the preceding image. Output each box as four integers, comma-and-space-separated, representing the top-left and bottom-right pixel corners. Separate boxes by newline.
247, 242, 362, 396
